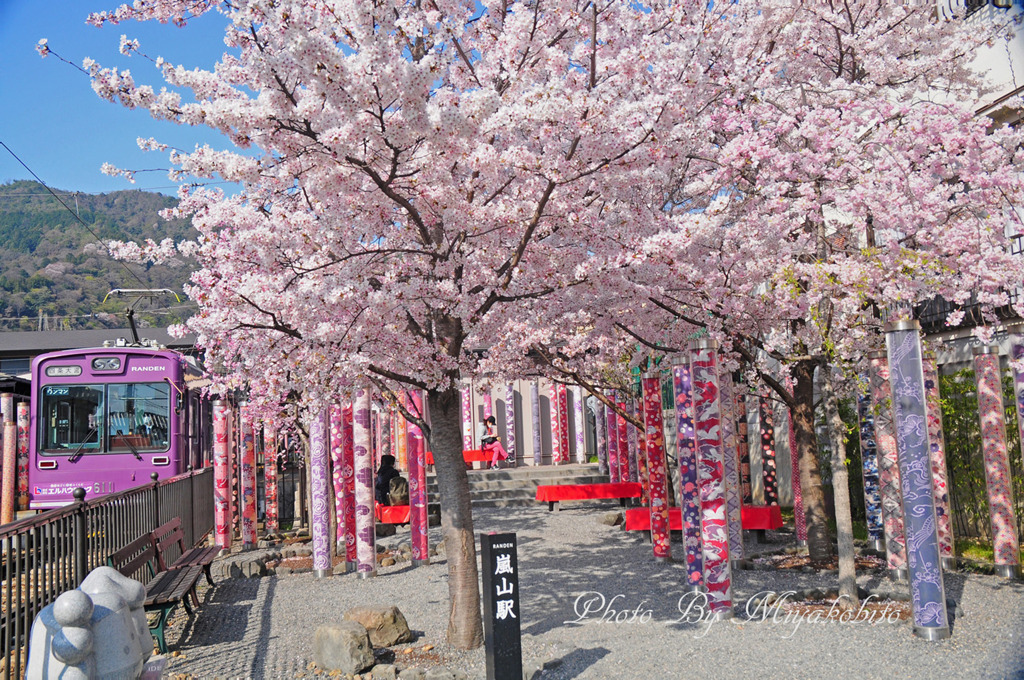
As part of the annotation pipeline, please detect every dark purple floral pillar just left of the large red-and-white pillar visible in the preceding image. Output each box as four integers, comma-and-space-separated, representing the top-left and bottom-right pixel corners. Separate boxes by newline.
672, 365, 703, 591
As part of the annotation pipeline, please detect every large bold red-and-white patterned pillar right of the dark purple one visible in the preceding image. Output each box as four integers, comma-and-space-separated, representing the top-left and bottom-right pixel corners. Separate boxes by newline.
689, 340, 732, 621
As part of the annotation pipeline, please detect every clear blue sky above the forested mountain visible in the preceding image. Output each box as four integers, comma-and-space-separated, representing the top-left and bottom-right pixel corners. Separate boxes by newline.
0, 0, 230, 195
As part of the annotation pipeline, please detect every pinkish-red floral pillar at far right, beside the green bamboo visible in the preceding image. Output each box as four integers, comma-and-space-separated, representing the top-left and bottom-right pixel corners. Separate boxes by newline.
970, 345, 1021, 579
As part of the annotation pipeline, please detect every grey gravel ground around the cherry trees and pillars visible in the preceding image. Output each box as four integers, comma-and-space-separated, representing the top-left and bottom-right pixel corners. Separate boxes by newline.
157, 504, 1024, 680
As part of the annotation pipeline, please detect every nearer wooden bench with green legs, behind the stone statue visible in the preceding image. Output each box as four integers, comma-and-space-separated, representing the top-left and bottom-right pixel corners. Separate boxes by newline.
106, 532, 203, 653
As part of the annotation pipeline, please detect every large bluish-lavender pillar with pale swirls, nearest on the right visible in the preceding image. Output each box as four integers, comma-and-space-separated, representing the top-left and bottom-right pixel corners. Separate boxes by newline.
886, 321, 949, 640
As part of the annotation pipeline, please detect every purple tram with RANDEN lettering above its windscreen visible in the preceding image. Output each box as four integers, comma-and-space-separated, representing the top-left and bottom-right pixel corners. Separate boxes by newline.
29, 346, 213, 509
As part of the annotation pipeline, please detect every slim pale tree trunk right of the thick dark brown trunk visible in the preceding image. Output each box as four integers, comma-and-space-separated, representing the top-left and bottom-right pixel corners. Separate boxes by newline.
821, 366, 859, 609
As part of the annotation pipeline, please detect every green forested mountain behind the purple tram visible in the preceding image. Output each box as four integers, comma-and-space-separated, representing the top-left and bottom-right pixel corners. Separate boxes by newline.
0, 181, 195, 331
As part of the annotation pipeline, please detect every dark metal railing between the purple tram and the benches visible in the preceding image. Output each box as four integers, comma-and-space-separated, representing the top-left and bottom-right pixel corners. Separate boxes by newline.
0, 468, 213, 680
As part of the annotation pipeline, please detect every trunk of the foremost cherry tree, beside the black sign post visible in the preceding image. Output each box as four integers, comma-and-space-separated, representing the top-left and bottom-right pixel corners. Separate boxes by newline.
427, 389, 483, 649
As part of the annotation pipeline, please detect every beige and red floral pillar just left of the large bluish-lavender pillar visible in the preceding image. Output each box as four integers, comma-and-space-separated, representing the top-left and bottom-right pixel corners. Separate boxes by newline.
867, 351, 906, 581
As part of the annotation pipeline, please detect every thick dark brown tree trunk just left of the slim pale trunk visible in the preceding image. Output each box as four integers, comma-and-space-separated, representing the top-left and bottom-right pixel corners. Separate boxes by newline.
793, 359, 833, 562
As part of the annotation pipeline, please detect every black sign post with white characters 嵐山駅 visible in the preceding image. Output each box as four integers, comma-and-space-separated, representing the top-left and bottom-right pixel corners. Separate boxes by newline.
480, 534, 522, 680
